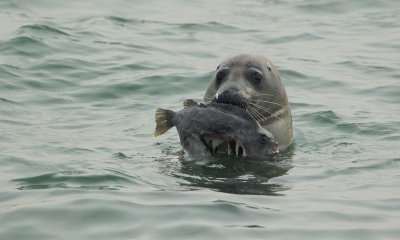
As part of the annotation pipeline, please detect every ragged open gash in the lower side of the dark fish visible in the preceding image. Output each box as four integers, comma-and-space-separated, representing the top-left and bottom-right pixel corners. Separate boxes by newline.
203, 133, 247, 157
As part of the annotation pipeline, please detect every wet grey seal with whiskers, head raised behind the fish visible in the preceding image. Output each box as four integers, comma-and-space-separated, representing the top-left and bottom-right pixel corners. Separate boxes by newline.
204, 54, 293, 150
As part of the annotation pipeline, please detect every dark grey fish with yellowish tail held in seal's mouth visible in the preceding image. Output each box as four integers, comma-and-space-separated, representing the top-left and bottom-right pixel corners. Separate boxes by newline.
154, 99, 279, 158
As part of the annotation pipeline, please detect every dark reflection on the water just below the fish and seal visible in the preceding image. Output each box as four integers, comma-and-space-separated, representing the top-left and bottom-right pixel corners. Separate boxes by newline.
172, 149, 293, 195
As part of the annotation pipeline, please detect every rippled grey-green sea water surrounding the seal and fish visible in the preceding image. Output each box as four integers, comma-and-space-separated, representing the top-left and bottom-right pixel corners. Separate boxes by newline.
0, 0, 400, 240
